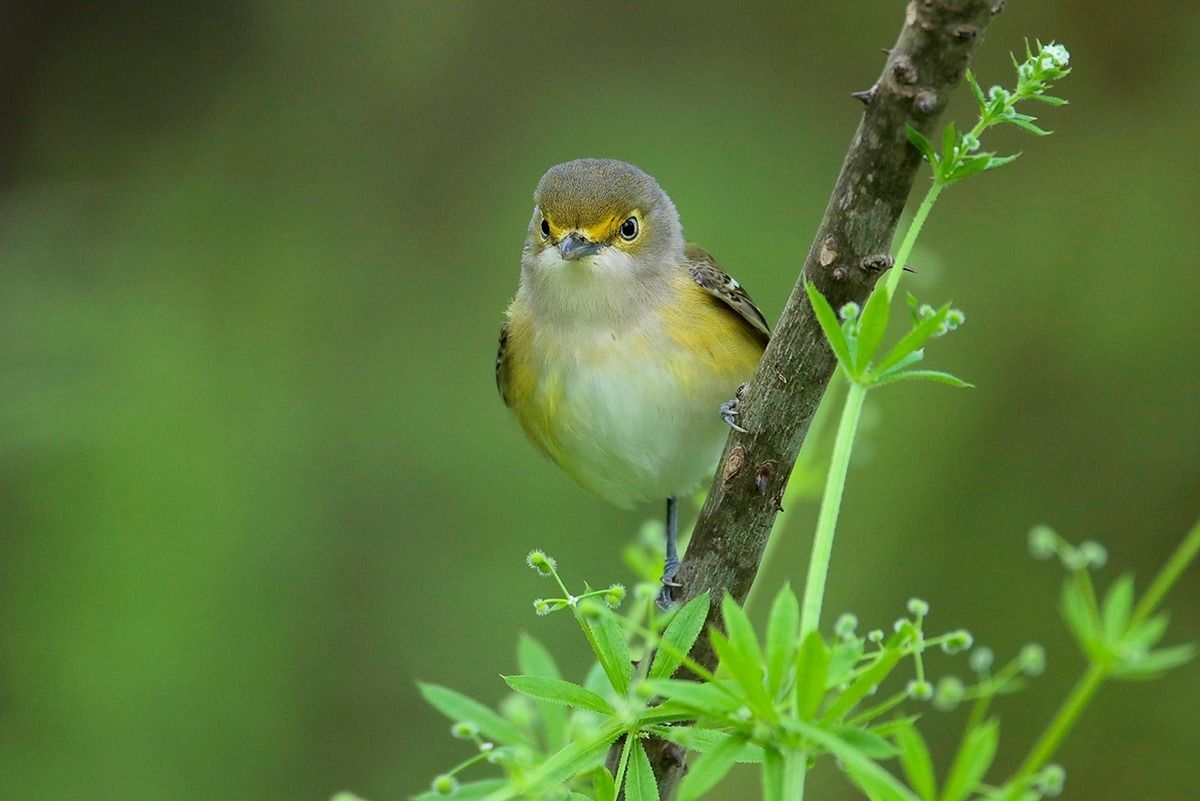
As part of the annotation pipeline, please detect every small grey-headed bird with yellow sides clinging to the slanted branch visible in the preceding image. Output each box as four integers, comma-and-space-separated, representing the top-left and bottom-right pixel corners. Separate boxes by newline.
496, 158, 770, 599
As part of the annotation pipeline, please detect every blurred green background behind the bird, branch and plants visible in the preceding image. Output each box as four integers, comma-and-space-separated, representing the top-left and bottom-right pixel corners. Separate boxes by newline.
0, 0, 1200, 801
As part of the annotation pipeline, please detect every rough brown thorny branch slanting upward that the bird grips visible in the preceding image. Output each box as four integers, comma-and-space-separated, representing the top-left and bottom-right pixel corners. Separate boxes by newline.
647, 0, 1003, 799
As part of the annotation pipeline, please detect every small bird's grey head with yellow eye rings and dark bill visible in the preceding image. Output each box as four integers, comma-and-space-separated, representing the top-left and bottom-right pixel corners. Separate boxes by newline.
522, 158, 684, 302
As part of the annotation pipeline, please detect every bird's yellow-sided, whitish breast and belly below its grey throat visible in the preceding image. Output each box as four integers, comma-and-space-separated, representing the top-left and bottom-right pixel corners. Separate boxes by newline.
505, 269, 762, 506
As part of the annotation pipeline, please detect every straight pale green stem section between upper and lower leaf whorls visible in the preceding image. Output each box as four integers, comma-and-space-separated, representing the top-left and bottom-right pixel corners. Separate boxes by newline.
800, 384, 866, 639
